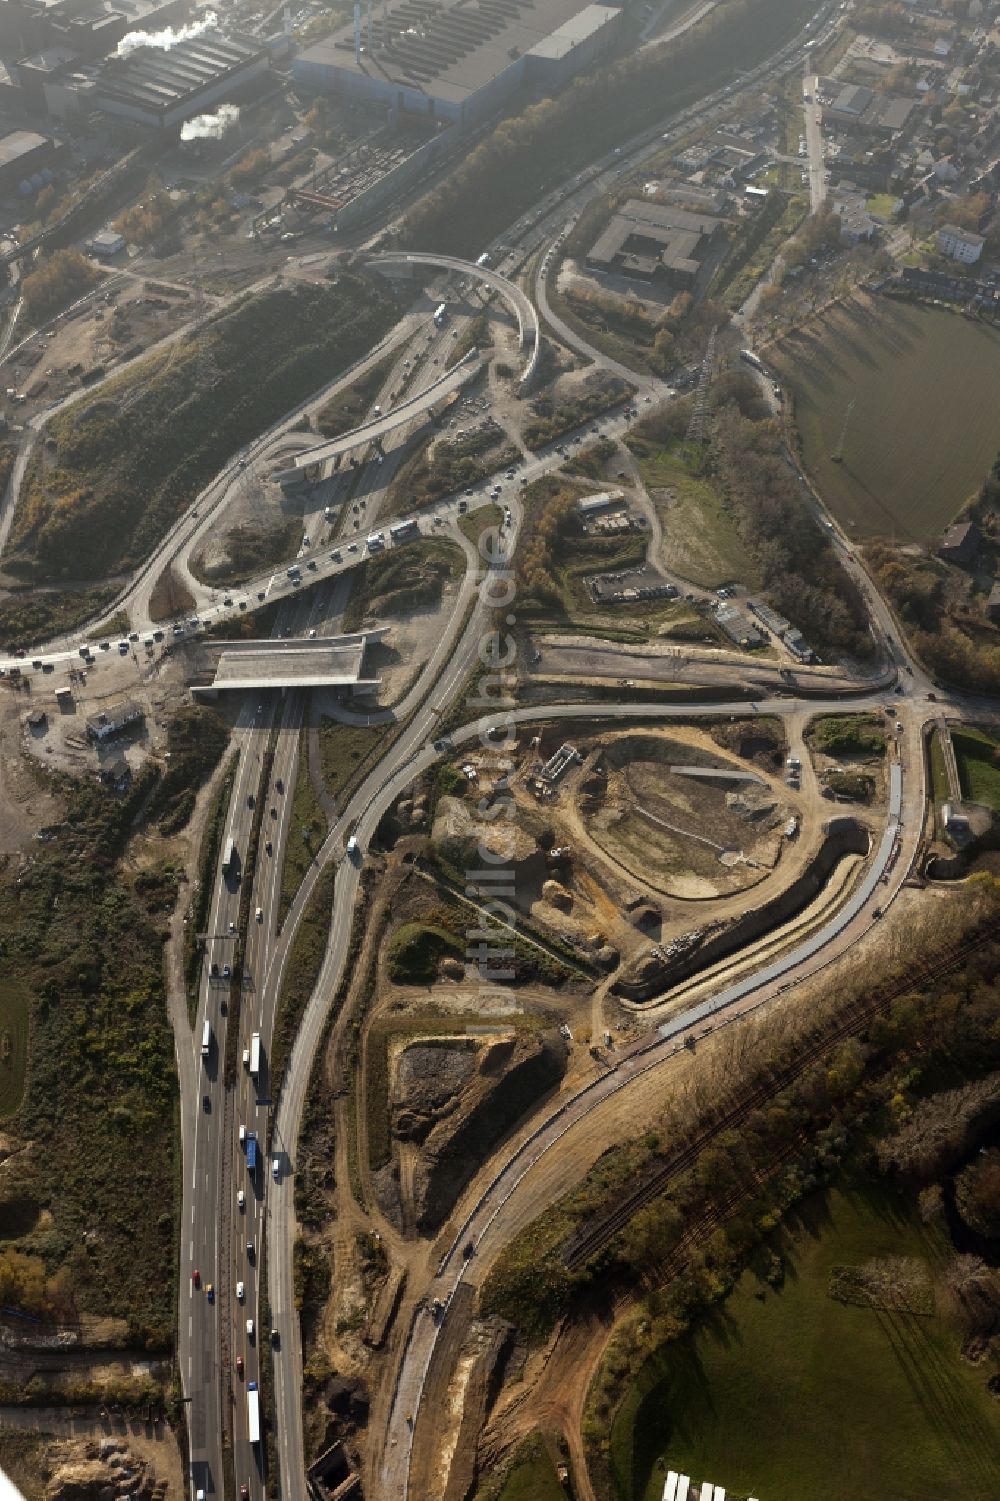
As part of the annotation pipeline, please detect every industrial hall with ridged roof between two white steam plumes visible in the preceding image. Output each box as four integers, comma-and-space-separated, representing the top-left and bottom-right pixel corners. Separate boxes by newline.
93, 32, 270, 131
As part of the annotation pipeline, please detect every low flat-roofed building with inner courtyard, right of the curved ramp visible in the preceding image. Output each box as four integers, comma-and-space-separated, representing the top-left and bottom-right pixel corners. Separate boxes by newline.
587, 198, 722, 288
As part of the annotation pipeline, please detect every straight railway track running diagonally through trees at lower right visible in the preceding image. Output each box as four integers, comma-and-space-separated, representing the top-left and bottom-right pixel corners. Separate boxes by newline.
563, 931, 989, 1271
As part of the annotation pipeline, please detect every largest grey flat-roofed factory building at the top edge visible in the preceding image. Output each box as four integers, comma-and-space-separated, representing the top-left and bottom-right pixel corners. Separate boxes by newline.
293, 0, 623, 126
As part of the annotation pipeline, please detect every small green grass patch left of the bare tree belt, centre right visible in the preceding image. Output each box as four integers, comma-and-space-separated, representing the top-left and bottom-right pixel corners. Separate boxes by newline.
630, 444, 757, 588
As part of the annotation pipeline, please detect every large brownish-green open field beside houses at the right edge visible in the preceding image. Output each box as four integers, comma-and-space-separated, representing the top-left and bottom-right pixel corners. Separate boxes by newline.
767, 297, 1000, 543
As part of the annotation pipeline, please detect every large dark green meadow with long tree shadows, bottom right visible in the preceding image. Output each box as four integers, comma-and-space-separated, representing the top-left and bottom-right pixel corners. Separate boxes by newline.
611, 1183, 1000, 1501
